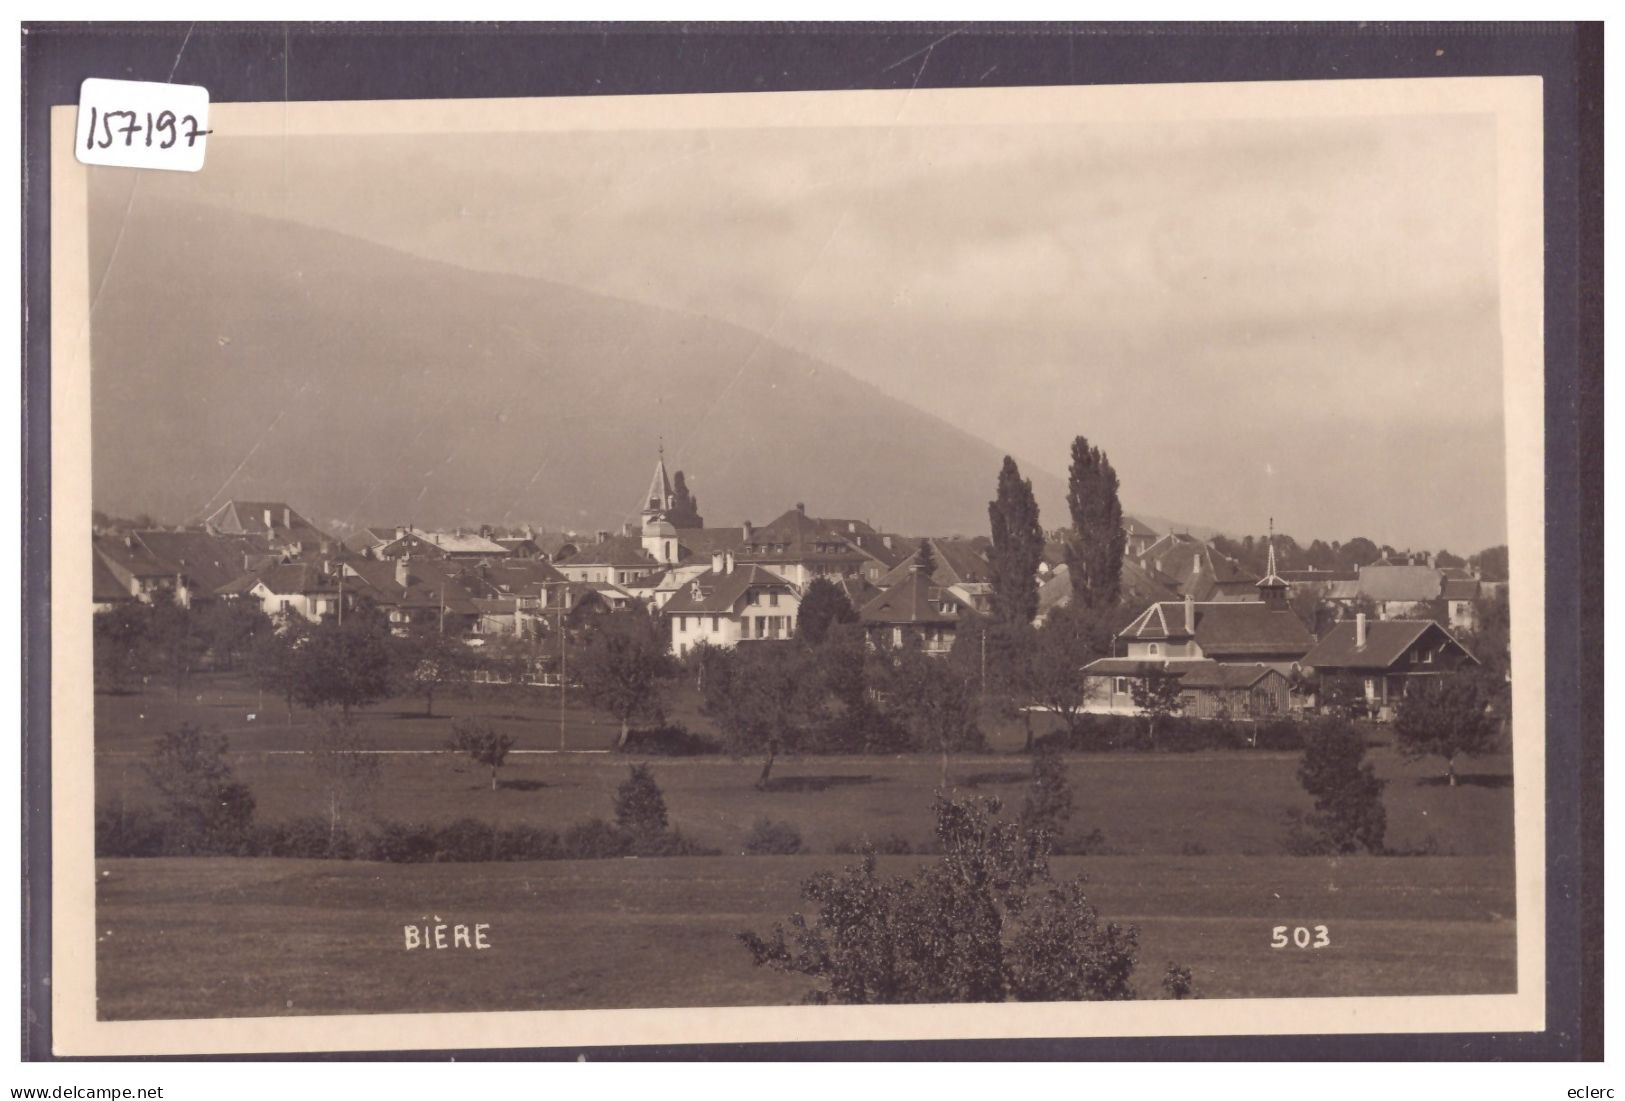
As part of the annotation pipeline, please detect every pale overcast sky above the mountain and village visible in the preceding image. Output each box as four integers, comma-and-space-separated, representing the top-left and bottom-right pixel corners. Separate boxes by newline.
123, 115, 1506, 552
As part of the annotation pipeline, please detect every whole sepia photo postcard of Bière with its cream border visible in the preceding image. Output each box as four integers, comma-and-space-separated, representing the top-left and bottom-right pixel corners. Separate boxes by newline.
52, 71, 1545, 1054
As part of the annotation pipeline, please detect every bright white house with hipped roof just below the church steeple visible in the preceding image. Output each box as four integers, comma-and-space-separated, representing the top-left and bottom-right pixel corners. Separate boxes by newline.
661, 551, 801, 658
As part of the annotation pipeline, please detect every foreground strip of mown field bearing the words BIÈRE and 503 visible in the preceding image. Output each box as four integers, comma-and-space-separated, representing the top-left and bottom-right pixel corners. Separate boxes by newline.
96, 856, 1516, 1020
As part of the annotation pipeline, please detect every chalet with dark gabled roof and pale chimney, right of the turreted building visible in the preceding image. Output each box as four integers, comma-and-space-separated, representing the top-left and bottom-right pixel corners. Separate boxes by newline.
1303, 612, 1479, 721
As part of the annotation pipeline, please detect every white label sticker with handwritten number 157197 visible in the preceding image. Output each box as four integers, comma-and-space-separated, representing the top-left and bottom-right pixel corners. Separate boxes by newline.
75, 78, 210, 172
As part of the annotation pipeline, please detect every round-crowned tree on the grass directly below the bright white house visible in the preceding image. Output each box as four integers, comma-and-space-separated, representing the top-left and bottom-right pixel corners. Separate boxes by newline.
705, 643, 819, 788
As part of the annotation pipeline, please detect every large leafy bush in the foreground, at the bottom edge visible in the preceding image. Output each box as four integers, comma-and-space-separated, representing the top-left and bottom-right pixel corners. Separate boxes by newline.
739, 796, 1139, 1005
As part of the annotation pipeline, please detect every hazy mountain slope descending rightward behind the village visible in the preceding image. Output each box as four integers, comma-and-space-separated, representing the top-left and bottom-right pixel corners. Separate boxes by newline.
91, 198, 1183, 534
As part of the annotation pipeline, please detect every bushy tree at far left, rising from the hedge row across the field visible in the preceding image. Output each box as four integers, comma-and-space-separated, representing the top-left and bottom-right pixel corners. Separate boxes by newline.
145, 723, 254, 853
